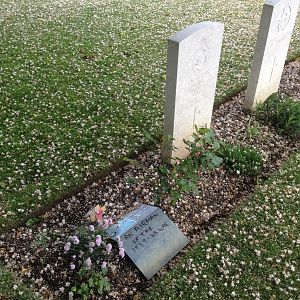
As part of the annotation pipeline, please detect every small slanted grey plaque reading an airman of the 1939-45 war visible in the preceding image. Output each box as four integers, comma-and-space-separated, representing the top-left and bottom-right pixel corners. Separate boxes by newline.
107, 204, 188, 279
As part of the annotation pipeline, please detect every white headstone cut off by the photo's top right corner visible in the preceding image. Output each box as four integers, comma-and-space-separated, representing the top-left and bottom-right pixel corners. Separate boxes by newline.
245, 0, 299, 110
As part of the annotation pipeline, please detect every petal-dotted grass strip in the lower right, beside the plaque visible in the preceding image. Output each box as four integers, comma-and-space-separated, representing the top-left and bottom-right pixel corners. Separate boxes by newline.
143, 152, 300, 300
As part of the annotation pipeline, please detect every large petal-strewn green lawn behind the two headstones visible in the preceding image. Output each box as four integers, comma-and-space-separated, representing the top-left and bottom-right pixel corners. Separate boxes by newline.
0, 0, 300, 230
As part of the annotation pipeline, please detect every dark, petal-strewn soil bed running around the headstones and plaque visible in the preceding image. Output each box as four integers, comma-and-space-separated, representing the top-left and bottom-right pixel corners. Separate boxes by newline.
0, 61, 300, 300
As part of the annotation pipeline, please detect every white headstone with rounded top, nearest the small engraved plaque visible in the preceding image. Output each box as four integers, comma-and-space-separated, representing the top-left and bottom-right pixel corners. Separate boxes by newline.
163, 22, 224, 161
